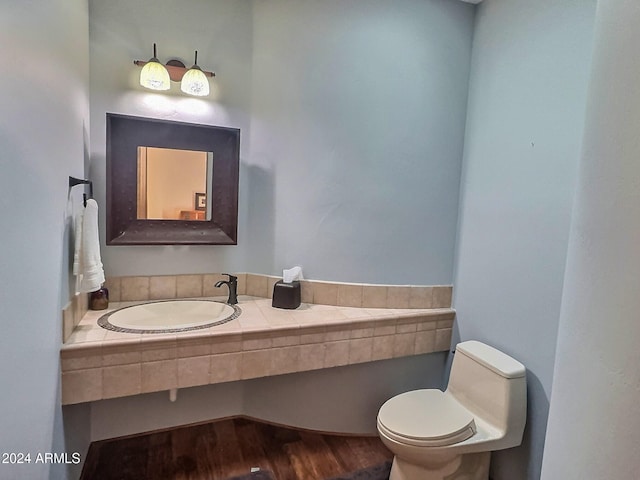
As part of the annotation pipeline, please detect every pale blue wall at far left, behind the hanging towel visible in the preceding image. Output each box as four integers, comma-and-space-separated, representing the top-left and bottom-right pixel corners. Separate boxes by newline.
0, 0, 89, 479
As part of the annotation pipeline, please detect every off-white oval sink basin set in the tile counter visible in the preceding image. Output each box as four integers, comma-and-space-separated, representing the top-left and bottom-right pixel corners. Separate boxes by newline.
98, 300, 241, 333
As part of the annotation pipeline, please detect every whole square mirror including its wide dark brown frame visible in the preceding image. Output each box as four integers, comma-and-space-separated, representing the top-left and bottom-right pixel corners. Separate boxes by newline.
107, 113, 240, 245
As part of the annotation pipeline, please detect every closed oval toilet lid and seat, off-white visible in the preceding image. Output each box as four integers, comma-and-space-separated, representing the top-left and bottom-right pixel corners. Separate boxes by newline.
378, 389, 476, 447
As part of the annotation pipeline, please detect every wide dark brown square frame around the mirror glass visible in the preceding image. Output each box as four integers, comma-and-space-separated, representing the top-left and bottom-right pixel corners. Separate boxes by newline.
107, 113, 240, 245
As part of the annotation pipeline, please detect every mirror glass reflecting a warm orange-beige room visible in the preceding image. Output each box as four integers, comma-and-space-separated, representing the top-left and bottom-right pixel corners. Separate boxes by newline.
137, 146, 213, 221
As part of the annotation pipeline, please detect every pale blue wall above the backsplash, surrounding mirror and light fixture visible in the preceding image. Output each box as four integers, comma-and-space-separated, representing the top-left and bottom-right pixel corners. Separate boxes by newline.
90, 0, 474, 284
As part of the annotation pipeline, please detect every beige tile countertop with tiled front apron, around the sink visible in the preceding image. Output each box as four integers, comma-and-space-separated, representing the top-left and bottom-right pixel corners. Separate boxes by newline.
60, 296, 455, 404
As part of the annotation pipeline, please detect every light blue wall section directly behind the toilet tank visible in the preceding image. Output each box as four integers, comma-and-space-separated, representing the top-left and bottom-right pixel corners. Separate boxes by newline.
454, 0, 596, 480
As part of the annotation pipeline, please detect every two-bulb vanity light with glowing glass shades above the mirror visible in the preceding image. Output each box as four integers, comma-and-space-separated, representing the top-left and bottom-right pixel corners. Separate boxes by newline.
133, 43, 216, 97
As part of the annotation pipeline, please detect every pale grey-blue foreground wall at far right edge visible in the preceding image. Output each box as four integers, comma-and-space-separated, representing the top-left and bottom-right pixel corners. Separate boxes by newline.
541, 0, 640, 480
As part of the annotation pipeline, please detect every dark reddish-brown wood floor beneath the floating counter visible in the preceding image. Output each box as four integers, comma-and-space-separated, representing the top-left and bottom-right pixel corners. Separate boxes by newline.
81, 418, 393, 480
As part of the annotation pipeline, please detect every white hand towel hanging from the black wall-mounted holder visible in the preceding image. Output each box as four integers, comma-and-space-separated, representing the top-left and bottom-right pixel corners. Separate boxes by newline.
80, 199, 105, 292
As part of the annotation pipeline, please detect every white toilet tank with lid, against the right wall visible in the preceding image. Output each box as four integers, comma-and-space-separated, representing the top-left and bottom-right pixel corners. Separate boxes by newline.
447, 340, 527, 442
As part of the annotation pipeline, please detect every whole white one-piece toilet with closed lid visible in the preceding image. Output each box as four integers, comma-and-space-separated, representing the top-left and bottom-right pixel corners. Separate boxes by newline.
378, 340, 527, 480
